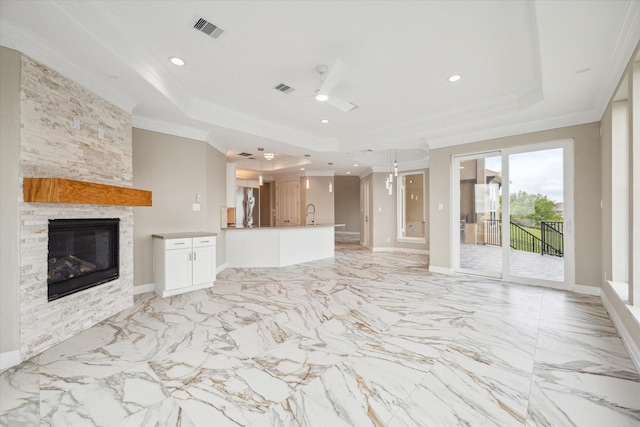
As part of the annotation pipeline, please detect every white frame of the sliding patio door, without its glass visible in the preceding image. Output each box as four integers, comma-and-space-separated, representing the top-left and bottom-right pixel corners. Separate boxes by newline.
451, 138, 575, 289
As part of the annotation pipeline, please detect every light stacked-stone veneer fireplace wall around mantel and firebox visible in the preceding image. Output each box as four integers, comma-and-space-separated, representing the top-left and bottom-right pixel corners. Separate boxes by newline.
20, 55, 133, 360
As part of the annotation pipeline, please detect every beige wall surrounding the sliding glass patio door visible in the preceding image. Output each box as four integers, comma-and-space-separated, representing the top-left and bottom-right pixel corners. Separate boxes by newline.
429, 123, 602, 286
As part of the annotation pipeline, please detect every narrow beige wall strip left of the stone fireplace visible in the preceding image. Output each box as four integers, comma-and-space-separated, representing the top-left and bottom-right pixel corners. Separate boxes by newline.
0, 47, 22, 353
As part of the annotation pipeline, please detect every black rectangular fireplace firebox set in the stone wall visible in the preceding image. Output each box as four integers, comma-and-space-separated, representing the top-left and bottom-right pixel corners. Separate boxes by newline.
47, 218, 120, 301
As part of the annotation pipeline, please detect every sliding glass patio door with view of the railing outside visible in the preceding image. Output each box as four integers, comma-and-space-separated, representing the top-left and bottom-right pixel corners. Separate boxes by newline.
452, 141, 574, 286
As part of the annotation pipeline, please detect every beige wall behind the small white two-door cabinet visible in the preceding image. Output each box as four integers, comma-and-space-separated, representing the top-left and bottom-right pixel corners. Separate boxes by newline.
133, 128, 226, 285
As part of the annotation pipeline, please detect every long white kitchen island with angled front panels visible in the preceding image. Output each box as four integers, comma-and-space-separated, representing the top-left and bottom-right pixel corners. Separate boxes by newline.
225, 224, 339, 268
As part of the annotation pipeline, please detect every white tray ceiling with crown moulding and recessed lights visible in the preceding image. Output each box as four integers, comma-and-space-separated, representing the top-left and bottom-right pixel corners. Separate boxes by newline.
0, 0, 640, 174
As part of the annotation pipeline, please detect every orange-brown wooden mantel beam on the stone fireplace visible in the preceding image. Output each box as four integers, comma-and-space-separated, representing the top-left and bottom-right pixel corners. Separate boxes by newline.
22, 178, 151, 206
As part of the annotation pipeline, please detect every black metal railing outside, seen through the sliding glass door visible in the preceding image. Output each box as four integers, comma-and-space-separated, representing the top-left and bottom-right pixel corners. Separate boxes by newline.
485, 219, 564, 257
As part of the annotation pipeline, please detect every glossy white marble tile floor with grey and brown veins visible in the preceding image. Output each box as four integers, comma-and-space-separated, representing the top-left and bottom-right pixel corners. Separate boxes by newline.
0, 242, 640, 427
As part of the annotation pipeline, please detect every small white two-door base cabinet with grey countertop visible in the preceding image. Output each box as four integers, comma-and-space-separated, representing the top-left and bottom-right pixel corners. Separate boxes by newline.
153, 233, 216, 297
